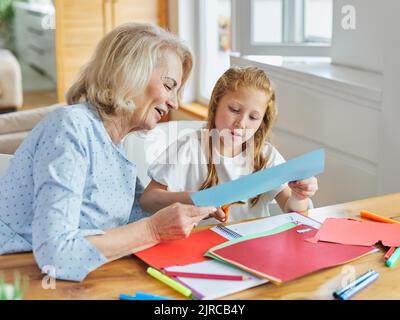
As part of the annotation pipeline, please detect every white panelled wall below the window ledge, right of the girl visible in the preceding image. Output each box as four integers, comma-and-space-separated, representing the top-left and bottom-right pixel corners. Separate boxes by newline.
231, 57, 381, 206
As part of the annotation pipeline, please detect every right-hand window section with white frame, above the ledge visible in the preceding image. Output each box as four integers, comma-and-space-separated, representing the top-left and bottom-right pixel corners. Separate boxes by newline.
233, 0, 333, 56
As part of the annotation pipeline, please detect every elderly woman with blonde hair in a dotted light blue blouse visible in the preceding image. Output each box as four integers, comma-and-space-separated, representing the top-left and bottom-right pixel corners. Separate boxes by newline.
0, 24, 220, 281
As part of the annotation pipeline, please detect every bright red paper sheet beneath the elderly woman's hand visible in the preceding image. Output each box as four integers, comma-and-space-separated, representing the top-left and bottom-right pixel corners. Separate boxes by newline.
134, 229, 227, 269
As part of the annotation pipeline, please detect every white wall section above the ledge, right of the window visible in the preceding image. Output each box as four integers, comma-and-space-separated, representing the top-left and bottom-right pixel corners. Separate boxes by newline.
331, 0, 384, 72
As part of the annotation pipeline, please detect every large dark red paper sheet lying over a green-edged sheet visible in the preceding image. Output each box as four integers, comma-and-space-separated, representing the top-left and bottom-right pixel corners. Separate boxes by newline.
212, 226, 374, 284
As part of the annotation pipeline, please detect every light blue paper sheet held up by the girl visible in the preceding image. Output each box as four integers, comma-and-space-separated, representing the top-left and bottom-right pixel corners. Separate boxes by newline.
190, 149, 325, 207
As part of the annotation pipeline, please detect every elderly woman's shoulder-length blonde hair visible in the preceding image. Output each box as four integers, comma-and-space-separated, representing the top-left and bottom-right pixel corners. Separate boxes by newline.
66, 23, 193, 119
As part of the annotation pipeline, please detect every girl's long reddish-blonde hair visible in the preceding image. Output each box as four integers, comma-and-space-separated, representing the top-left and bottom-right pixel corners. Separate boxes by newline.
200, 67, 277, 206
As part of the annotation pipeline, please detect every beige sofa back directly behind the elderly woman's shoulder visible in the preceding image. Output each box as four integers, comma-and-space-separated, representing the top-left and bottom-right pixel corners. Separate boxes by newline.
0, 104, 63, 154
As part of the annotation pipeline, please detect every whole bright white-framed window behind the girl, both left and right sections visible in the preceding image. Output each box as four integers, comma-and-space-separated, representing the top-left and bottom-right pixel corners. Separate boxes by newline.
196, 0, 333, 103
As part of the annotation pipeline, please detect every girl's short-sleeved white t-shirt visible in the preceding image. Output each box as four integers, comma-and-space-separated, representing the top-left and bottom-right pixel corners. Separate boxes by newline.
147, 130, 287, 222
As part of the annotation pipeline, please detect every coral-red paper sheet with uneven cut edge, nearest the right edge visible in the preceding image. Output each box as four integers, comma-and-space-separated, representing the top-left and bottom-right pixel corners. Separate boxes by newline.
308, 218, 400, 247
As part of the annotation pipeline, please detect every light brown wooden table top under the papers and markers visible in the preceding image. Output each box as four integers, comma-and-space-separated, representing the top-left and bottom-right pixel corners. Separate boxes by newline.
0, 193, 400, 299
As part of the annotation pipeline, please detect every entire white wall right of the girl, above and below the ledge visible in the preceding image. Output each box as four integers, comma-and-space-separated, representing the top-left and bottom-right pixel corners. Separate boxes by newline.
232, 0, 400, 206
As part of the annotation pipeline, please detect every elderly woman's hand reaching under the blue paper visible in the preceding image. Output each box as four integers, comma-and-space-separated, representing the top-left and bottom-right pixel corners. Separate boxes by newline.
148, 203, 217, 242
